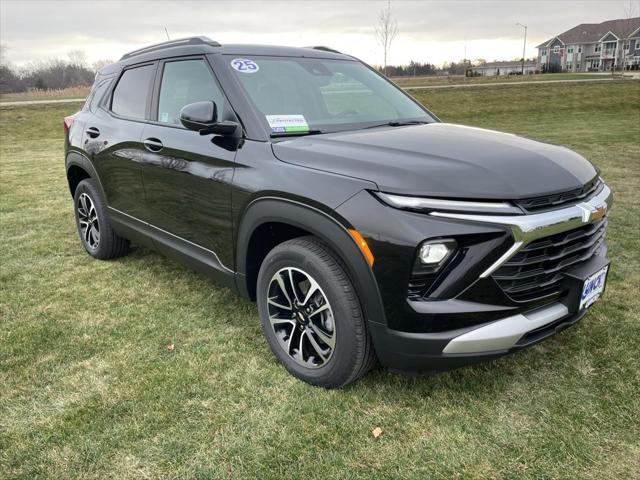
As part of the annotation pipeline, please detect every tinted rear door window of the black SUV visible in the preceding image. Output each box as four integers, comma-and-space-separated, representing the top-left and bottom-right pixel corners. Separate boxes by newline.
111, 65, 153, 118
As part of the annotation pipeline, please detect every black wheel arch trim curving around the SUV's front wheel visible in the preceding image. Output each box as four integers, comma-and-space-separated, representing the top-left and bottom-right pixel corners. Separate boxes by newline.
236, 196, 386, 324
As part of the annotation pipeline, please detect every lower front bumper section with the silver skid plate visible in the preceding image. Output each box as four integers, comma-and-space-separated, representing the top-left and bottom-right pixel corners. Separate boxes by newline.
369, 244, 609, 371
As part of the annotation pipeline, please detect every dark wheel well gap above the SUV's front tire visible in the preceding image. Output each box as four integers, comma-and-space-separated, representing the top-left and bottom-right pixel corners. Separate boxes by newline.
246, 222, 311, 300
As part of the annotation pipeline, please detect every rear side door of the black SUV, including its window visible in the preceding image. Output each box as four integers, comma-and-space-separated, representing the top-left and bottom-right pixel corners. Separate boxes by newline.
88, 63, 156, 218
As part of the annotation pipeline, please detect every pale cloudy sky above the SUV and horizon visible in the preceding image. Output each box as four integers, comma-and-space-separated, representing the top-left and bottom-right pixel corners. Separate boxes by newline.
0, 0, 639, 66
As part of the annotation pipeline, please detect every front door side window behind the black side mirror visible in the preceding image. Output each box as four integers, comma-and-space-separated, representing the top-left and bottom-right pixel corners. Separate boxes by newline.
158, 60, 224, 125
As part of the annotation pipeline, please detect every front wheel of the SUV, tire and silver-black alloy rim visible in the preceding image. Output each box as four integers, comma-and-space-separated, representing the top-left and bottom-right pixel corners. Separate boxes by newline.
257, 237, 375, 388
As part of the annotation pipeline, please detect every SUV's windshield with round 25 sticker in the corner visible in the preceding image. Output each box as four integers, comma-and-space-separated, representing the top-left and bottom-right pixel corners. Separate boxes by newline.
227, 55, 434, 136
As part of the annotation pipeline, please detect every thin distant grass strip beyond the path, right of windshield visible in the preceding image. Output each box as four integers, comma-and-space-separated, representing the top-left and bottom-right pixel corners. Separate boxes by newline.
391, 72, 620, 88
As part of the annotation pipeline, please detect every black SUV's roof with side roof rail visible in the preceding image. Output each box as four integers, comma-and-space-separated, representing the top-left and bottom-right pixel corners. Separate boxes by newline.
99, 37, 355, 76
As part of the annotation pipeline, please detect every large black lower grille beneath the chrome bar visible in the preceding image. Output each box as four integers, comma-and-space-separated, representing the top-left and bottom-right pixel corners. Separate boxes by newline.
493, 217, 608, 302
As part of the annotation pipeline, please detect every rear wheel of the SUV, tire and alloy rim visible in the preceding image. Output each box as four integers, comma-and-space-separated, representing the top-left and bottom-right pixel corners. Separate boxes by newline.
73, 178, 129, 260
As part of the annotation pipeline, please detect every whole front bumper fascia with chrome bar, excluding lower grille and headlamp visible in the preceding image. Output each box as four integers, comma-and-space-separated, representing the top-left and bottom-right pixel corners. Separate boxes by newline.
336, 186, 612, 371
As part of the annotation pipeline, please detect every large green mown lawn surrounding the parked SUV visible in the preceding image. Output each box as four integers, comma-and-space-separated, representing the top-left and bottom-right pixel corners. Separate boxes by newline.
0, 81, 640, 480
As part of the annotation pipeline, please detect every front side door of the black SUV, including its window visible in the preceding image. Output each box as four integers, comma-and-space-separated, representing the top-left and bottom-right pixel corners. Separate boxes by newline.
142, 57, 235, 266
